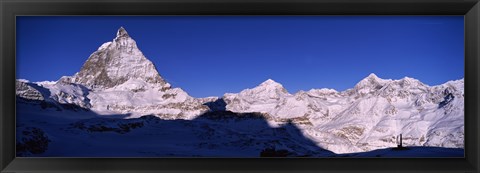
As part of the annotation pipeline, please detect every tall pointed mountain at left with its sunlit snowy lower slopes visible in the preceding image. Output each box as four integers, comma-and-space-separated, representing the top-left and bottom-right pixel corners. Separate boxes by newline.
17, 27, 208, 119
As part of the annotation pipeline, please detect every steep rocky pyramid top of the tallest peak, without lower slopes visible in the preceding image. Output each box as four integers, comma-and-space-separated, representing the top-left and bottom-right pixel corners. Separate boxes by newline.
71, 27, 170, 89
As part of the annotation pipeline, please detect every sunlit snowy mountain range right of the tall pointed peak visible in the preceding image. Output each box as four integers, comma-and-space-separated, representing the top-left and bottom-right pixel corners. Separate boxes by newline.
223, 74, 464, 153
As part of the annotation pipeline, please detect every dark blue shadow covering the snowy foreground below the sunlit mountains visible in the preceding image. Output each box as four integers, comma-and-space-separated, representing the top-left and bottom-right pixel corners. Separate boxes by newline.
17, 99, 463, 157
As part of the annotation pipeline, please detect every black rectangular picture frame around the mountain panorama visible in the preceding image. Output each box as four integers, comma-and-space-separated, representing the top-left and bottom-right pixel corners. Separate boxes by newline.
0, 0, 480, 173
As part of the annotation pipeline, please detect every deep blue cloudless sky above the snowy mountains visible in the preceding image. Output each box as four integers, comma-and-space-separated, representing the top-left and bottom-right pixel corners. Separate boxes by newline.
16, 16, 464, 97
